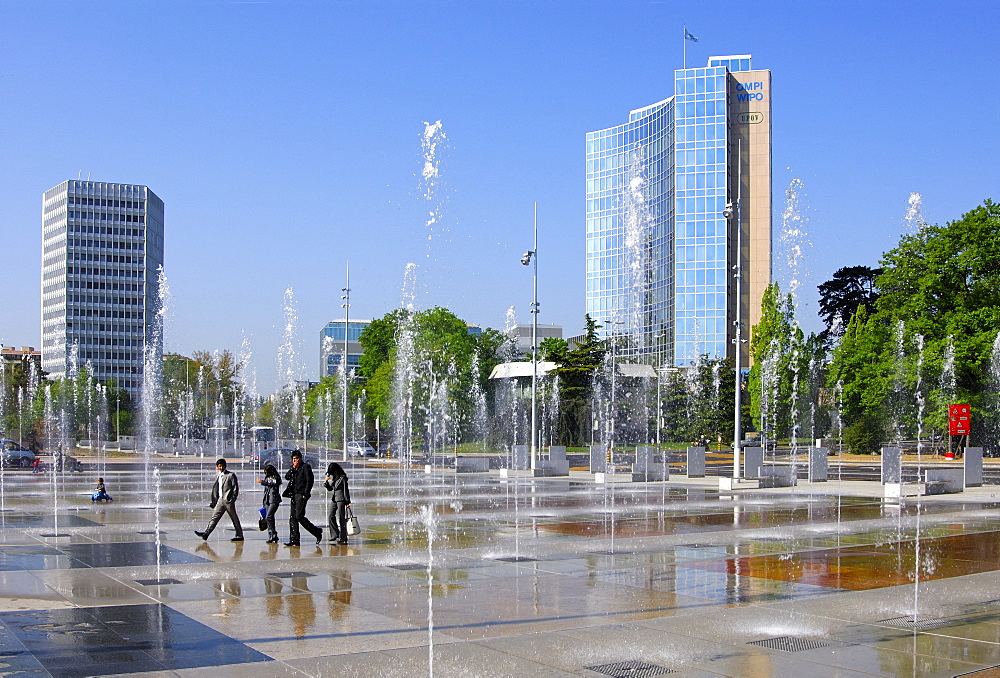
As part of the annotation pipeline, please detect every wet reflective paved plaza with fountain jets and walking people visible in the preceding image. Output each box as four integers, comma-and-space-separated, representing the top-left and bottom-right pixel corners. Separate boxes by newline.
0, 461, 1000, 677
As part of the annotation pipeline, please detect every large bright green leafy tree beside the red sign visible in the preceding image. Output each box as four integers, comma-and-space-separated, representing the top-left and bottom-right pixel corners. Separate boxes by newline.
828, 200, 1000, 442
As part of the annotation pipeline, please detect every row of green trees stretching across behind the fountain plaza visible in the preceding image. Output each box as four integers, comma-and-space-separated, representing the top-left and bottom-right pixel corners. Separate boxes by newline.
0, 201, 1000, 451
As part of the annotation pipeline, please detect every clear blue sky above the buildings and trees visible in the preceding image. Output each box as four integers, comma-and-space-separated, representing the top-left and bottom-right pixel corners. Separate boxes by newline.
0, 0, 1000, 390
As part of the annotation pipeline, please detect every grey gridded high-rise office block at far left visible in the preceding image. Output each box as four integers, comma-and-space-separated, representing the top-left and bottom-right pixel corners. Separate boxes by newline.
42, 181, 163, 396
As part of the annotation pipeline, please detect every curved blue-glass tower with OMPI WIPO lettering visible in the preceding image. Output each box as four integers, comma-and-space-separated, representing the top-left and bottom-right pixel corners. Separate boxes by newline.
586, 55, 771, 366
